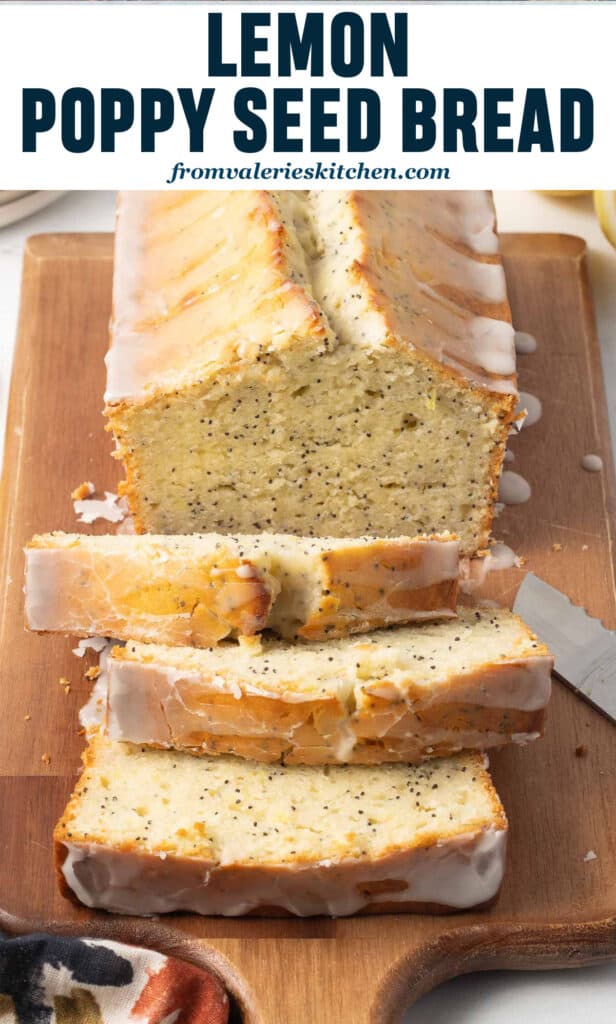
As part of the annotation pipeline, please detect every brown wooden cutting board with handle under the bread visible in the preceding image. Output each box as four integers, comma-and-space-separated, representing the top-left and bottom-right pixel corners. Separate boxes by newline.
0, 234, 616, 1024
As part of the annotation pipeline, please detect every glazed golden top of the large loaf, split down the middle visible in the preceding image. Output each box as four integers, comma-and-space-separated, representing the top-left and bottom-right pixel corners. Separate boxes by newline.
105, 190, 516, 404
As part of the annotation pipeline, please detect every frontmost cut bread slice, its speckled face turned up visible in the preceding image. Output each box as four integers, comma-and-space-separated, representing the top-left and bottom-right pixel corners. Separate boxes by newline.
54, 737, 507, 916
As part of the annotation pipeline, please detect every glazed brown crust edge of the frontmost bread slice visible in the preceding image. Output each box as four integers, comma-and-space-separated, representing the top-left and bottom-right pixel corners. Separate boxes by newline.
60, 826, 507, 918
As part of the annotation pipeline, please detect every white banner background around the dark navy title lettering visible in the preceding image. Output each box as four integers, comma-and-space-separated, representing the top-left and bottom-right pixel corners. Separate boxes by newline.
0, 2, 616, 188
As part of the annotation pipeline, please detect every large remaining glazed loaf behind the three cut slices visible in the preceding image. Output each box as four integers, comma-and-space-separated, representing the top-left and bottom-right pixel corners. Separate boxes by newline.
106, 190, 517, 555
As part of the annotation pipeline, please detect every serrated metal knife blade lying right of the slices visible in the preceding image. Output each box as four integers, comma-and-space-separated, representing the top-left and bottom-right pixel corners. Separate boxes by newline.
514, 572, 616, 723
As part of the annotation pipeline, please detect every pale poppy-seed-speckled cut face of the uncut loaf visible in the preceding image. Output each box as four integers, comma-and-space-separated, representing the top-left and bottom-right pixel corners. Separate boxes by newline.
109, 345, 511, 555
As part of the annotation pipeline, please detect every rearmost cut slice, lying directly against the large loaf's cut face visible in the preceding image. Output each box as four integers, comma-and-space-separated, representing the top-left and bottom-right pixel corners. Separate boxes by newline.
26, 534, 458, 647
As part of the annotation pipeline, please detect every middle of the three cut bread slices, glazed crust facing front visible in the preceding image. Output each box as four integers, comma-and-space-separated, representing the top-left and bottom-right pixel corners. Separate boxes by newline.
107, 609, 553, 764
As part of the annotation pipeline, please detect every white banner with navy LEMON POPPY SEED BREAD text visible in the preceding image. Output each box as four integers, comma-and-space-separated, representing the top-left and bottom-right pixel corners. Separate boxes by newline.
0, 0, 616, 189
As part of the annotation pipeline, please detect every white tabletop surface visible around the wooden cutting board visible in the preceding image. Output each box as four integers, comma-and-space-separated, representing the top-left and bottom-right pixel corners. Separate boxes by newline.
0, 193, 616, 1024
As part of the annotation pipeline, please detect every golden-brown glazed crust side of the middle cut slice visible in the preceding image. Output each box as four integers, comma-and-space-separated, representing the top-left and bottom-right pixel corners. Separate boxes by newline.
112, 616, 554, 765
